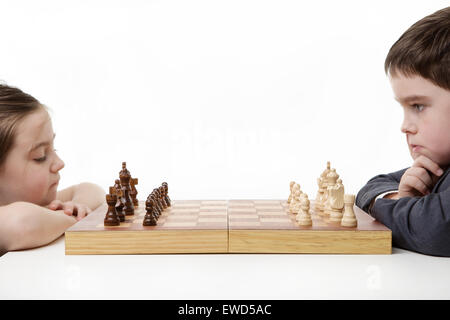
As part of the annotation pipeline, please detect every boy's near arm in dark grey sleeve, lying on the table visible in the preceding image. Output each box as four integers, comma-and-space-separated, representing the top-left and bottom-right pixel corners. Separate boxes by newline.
371, 189, 450, 256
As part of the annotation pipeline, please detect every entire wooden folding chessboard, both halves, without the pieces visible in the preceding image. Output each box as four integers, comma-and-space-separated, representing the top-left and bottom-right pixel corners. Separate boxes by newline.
65, 200, 392, 255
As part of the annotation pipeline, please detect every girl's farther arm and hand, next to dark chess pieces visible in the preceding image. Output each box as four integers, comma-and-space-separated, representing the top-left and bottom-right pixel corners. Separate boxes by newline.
56, 182, 105, 210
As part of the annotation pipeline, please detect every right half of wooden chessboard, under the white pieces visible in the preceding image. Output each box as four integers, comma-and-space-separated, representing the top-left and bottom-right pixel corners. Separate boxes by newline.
228, 200, 392, 254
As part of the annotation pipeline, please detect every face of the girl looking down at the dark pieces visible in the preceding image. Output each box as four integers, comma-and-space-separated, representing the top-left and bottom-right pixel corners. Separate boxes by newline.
0, 108, 64, 206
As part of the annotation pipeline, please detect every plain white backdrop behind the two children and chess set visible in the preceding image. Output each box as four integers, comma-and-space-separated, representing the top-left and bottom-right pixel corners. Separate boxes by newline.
0, 0, 448, 199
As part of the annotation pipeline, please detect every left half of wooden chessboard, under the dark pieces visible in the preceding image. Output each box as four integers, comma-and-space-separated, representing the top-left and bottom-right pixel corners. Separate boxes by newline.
65, 200, 228, 254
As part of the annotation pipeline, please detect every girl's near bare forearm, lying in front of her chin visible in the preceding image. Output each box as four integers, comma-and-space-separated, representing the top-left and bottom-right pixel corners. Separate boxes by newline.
0, 202, 76, 251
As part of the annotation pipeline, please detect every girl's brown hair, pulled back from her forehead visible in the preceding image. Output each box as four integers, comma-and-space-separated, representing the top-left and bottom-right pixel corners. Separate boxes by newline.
0, 84, 45, 166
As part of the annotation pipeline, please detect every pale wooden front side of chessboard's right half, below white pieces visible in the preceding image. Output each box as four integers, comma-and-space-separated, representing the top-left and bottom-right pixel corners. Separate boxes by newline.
228, 229, 392, 254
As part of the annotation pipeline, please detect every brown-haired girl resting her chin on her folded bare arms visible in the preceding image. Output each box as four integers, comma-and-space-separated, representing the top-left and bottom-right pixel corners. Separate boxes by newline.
0, 85, 105, 255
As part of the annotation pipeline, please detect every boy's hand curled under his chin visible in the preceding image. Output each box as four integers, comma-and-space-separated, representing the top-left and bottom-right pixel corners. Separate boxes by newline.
398, 155, 444, 198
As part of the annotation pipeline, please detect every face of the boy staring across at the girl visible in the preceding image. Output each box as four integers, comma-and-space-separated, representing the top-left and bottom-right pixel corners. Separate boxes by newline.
390, 73, 450, 168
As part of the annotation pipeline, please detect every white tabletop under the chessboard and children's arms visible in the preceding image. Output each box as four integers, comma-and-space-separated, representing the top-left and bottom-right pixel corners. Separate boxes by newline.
0, 236, 450, 300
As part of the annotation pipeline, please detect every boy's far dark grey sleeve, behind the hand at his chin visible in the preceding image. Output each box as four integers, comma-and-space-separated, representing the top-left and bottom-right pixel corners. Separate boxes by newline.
356, 168, 407, 213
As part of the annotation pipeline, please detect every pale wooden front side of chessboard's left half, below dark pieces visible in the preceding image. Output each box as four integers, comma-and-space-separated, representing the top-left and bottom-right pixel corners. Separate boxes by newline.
65, 230, 228, 255
